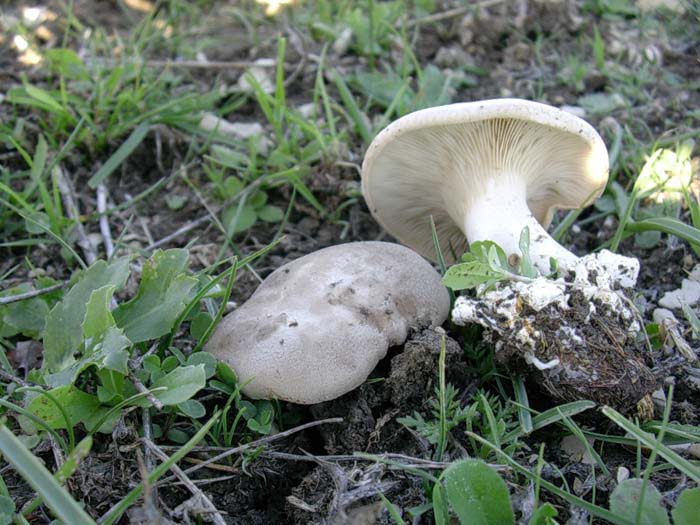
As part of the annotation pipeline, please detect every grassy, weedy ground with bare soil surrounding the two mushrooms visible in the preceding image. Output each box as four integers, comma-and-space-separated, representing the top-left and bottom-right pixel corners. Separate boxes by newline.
0, 0, 700, 524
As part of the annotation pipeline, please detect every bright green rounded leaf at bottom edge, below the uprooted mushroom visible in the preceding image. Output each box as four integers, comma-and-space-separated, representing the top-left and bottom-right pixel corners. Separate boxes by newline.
441, 459, 515, 525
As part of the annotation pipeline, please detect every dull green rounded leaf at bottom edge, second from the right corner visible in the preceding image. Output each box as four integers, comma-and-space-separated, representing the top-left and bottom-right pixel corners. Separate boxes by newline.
610, 478, 669, 525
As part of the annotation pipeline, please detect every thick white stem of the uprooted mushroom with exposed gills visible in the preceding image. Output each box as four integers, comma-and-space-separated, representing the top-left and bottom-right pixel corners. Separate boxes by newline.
464, 173, 578, 275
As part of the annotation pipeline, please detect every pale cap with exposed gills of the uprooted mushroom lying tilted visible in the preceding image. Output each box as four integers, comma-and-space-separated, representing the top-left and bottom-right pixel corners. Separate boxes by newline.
362, 99, 608, 261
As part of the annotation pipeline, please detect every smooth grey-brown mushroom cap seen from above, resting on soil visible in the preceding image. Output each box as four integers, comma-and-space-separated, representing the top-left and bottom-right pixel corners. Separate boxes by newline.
206, 242, 450, 404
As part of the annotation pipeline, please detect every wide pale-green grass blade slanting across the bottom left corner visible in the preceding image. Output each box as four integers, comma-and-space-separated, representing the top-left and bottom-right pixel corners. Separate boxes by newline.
0, 425, 95, 525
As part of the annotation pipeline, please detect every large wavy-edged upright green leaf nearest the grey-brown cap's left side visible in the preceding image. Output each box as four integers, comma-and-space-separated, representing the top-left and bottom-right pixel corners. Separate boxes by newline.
114, 249, 197, 343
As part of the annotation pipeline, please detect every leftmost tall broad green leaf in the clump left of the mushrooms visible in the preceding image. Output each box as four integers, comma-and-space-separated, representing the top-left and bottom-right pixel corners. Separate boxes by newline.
44, 258, 129, 372
